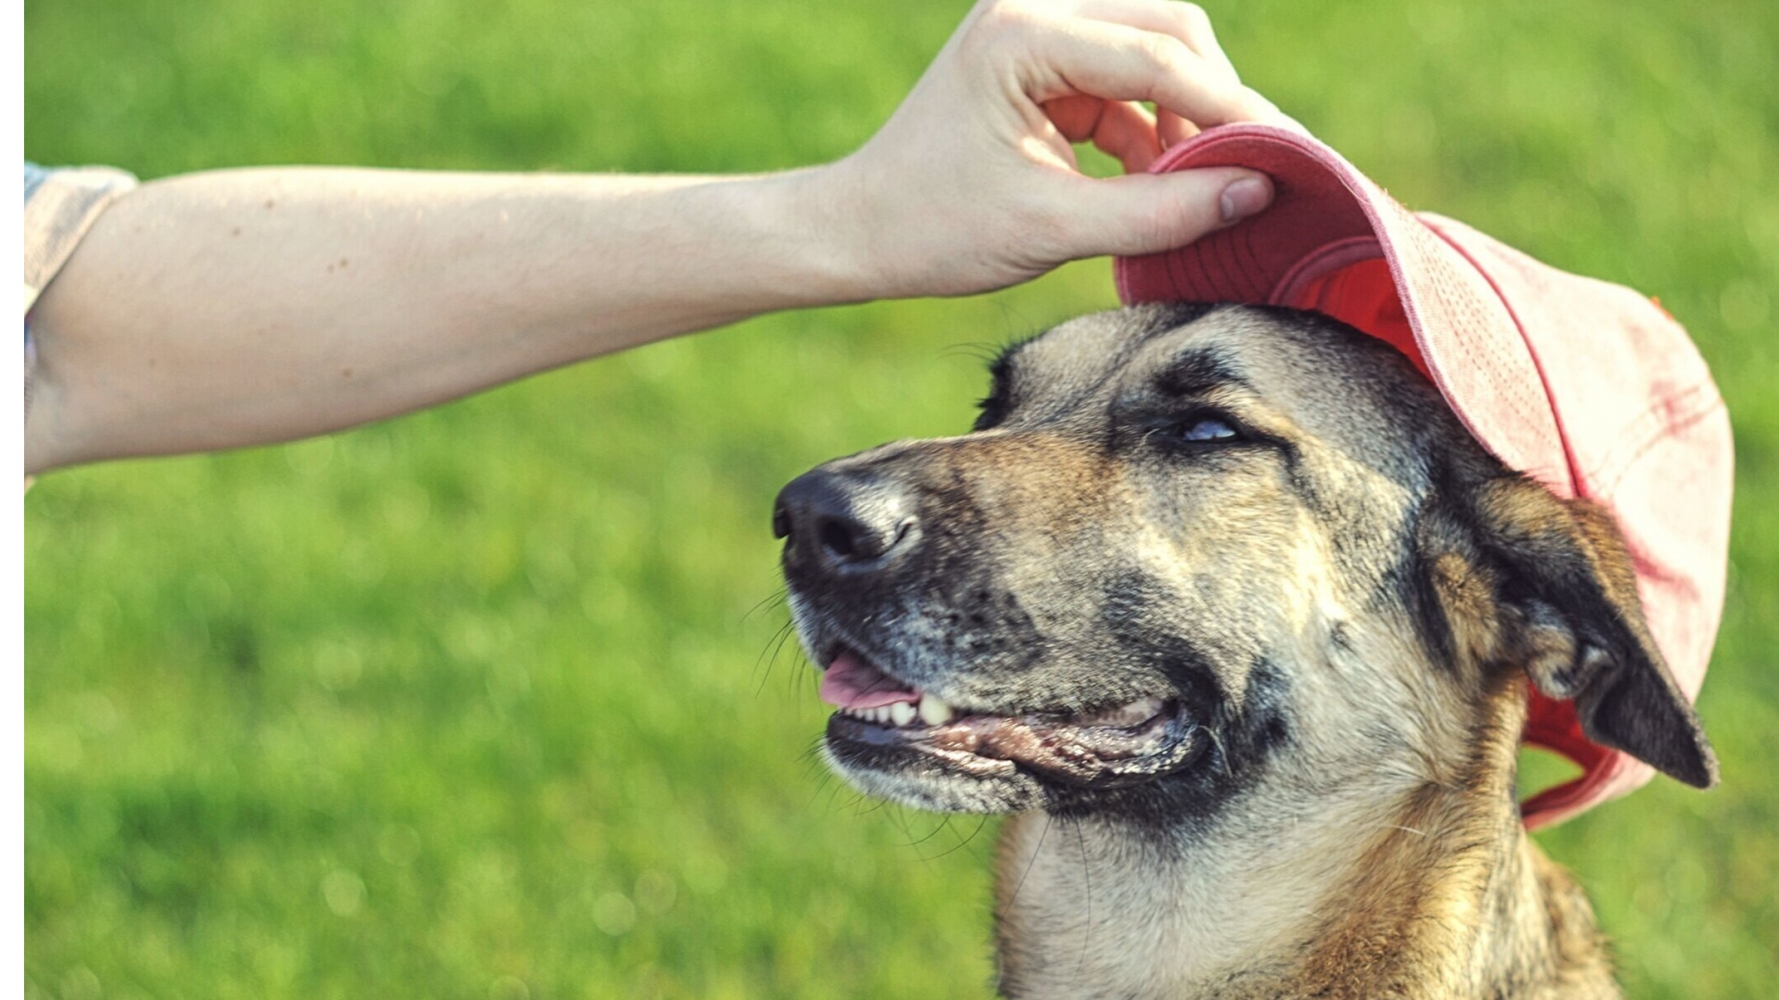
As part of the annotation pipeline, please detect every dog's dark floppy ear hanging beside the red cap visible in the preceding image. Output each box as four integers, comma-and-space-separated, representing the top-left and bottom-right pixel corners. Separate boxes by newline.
1473, 475, 1717, 788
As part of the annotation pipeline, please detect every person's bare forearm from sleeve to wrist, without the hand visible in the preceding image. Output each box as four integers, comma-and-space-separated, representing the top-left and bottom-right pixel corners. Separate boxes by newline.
25, 167, 861, 472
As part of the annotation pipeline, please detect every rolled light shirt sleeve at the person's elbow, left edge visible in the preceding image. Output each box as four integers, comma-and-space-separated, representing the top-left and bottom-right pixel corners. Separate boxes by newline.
25, 162, 135, 420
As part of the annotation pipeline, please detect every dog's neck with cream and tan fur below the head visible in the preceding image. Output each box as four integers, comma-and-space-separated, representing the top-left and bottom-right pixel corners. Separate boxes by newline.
996, 678, 1617, 1000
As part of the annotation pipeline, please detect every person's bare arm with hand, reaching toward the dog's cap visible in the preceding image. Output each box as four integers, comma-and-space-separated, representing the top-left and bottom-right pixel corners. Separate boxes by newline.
25, 0, 1277, 472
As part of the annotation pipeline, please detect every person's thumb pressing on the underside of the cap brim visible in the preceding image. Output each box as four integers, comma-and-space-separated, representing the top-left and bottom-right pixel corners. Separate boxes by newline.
1067, 167, 1272, 256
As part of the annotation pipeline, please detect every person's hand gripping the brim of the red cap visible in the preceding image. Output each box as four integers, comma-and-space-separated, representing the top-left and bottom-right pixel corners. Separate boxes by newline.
825, 0, 1302, 297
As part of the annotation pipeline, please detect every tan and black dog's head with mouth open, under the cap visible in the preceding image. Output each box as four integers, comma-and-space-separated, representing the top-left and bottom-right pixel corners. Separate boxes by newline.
774, 306, 1715, 822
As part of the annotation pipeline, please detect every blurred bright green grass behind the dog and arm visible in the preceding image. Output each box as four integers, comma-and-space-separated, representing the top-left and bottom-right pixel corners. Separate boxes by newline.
25, 0, 1779, 1000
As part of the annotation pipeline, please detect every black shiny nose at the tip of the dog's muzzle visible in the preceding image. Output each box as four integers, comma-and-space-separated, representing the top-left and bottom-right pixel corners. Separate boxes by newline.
772, 470, 918, 571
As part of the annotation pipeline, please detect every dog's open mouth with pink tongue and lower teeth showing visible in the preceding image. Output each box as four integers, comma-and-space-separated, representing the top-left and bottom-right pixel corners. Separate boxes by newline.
822, 648, 1201, 790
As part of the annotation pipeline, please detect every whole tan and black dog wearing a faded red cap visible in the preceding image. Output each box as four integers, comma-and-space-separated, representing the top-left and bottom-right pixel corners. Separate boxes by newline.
774, 306, 1717, 1000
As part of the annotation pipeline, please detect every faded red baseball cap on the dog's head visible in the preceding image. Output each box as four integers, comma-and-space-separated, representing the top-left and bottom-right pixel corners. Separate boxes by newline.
1114, 125, 1733, 829
